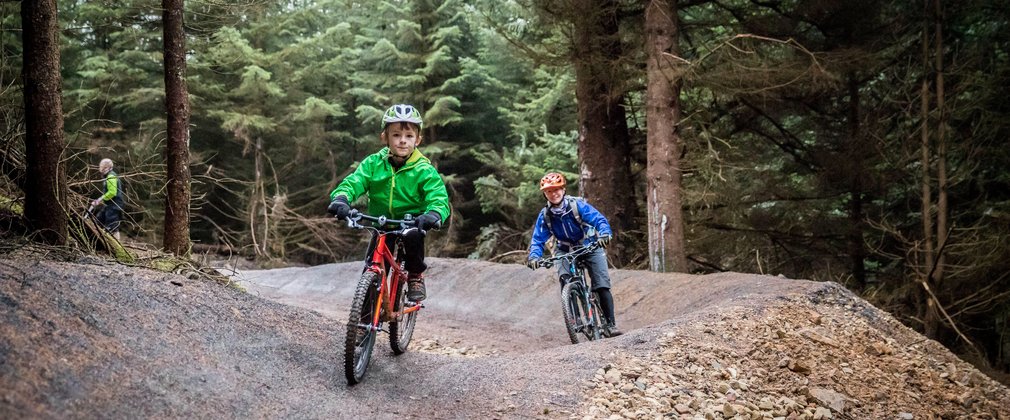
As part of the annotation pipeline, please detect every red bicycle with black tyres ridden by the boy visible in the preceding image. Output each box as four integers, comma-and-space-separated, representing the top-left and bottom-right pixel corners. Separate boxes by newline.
343, 210, 424, 385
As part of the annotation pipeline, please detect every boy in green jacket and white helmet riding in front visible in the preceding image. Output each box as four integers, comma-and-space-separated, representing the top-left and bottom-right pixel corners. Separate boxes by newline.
326, 104, 449, 302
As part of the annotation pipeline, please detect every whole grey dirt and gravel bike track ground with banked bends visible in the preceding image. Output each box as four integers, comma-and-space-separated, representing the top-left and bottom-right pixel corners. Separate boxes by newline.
0, 256, 1010, 419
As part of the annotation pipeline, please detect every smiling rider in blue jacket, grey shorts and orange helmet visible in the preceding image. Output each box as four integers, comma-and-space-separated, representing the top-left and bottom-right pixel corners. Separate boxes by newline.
526, 172, 621, 337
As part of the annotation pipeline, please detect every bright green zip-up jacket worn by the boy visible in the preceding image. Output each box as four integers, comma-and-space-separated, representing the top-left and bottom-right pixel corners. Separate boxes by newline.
329, 147, 449, 223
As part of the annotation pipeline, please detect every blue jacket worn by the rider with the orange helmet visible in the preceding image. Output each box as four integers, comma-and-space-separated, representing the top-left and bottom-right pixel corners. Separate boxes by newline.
527, 196, 613, 259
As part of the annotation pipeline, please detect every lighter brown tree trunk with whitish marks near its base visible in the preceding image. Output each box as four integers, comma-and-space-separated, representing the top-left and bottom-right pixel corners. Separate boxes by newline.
645, 0, 688, 273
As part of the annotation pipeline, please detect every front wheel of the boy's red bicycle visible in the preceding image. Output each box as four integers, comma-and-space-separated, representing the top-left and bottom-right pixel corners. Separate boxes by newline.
343, 271, 381, 385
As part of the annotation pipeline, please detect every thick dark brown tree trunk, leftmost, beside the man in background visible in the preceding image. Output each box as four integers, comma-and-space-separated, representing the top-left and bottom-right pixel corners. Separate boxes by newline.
21, 0, 69, 244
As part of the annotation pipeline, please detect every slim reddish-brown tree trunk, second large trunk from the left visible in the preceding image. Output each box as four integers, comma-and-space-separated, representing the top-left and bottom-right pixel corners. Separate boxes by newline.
162, 0, 190, 255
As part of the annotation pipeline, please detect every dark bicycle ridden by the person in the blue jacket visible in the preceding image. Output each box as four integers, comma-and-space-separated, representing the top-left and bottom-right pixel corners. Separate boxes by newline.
537, 242, 610, 344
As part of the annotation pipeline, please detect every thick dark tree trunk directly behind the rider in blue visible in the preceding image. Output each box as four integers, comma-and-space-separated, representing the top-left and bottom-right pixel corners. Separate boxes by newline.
572, 0, 636, 266
